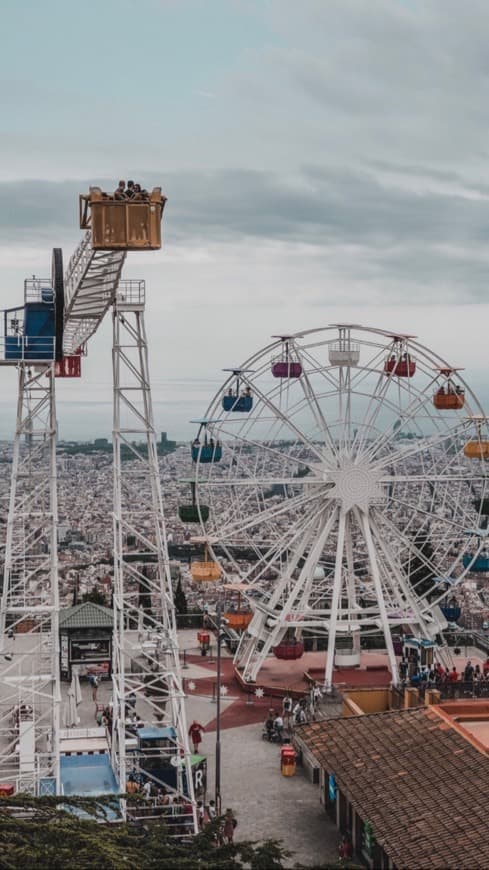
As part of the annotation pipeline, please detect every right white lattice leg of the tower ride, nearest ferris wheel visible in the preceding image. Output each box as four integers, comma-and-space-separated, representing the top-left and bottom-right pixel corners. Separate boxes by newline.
112, 282, 198, 832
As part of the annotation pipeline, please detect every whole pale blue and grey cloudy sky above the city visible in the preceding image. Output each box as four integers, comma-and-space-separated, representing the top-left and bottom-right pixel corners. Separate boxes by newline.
0, 0, 489, 437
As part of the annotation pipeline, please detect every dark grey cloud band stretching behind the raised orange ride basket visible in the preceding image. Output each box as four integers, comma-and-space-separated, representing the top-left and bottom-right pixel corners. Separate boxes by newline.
0, 166, 489, 301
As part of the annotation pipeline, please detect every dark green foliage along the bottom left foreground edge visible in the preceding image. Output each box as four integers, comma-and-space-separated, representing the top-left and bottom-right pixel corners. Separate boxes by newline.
0, 795, 289, 870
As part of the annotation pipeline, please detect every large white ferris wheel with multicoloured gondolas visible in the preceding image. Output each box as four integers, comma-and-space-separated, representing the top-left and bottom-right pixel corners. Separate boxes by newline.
192, 324, 489, 688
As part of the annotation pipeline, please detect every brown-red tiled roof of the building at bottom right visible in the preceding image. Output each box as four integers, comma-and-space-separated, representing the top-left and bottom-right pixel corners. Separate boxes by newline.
300, 708, 489, 870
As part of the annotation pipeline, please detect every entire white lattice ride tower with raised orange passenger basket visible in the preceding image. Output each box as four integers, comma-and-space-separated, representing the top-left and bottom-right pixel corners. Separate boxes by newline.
0, 188, 198, 832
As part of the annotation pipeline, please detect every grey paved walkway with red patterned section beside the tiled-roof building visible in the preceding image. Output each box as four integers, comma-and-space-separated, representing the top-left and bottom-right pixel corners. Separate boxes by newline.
0, 632, 339, 867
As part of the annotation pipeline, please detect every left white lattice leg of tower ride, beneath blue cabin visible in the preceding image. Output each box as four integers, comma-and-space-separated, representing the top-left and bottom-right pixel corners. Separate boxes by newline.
0, 363, 61, 794
